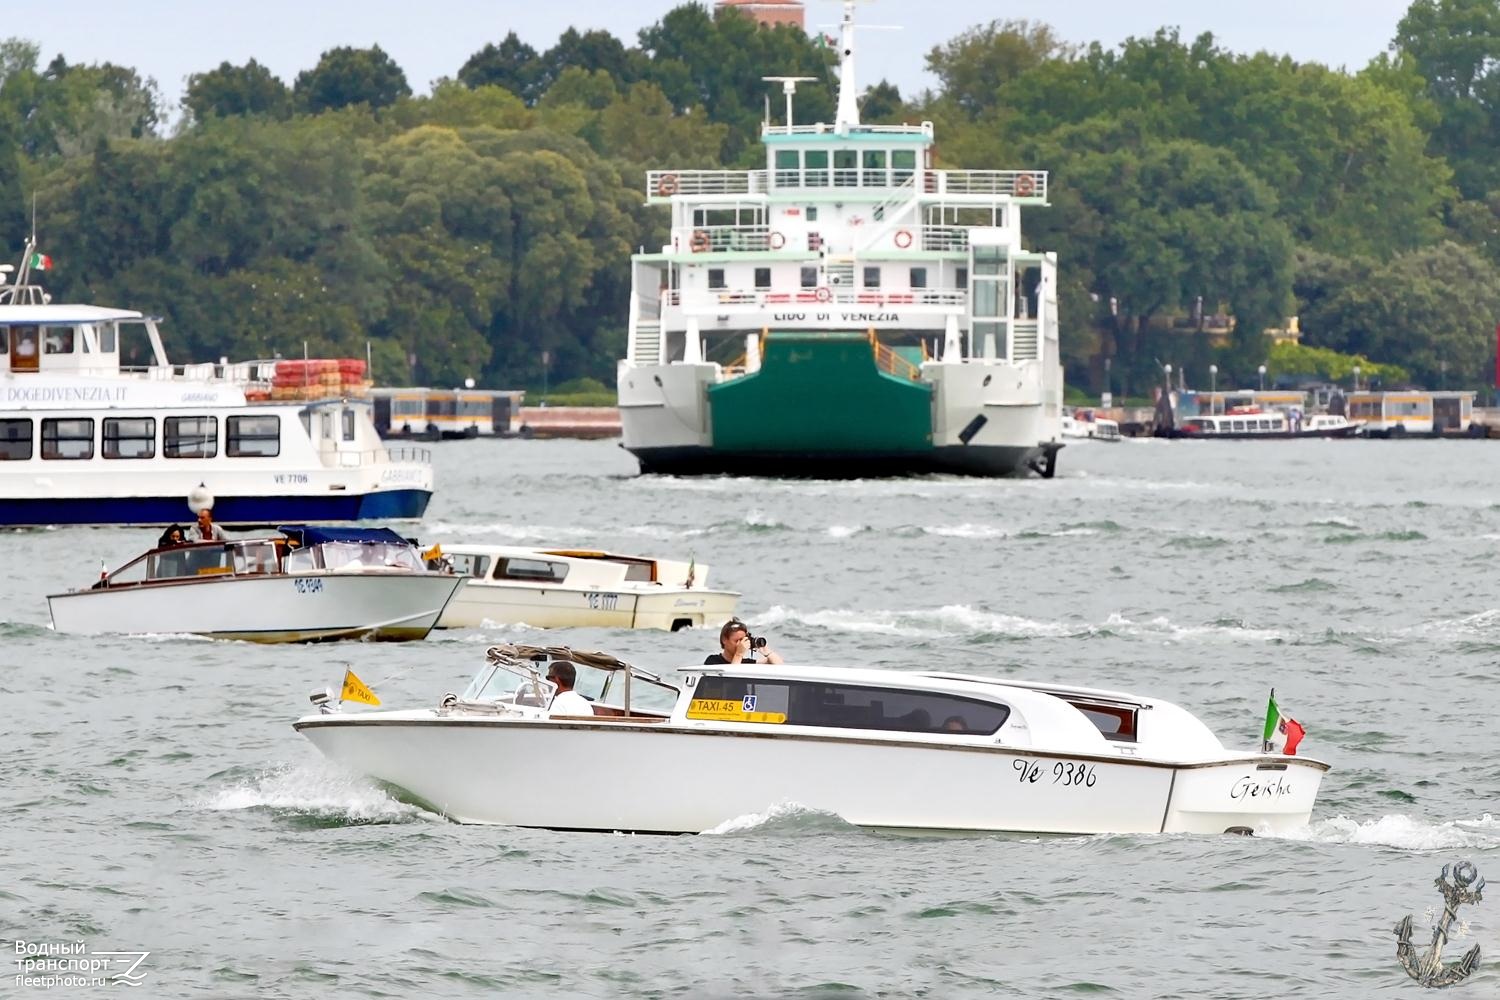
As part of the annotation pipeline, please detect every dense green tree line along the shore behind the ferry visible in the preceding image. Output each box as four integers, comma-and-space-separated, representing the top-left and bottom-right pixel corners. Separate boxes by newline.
0, 0, 1500, 393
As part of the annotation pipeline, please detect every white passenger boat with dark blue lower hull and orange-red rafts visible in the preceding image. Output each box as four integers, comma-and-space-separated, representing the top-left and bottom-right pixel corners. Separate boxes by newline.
0, 240, 432, 526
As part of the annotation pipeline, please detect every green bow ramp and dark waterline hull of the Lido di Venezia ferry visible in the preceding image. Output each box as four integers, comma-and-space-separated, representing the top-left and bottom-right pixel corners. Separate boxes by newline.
630, 333, 1058, 478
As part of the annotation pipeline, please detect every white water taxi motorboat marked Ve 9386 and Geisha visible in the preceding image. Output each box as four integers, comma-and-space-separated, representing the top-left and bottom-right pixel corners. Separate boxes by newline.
296, 646, 1329, 834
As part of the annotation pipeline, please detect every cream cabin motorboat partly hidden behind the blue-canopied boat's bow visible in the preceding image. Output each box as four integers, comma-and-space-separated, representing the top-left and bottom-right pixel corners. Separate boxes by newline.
438, 541, 740, 631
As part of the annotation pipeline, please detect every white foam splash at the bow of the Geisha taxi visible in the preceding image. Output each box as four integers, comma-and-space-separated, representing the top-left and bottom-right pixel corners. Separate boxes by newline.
200, 765, 437, 826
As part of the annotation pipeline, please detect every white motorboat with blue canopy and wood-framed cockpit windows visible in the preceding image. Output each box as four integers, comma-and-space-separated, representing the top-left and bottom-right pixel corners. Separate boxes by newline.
47, 526, 464, 642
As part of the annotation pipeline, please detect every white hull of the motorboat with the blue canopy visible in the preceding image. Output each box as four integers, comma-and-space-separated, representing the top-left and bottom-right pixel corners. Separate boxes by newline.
47, 571, 462, 643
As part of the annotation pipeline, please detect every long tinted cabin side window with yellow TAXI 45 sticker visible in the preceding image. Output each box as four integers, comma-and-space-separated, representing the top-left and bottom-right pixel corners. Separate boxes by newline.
687, 675, 1011, 736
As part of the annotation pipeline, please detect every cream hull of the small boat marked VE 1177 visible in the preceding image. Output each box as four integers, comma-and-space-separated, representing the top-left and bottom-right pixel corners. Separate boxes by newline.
438, 579, 740, 631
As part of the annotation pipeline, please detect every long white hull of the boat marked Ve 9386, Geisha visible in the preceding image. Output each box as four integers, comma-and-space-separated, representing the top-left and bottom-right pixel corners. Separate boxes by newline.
296, 712, 1328, 834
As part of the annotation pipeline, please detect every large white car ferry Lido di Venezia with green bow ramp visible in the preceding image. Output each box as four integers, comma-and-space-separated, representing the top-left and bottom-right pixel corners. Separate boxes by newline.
618, 0, 1062, 477
